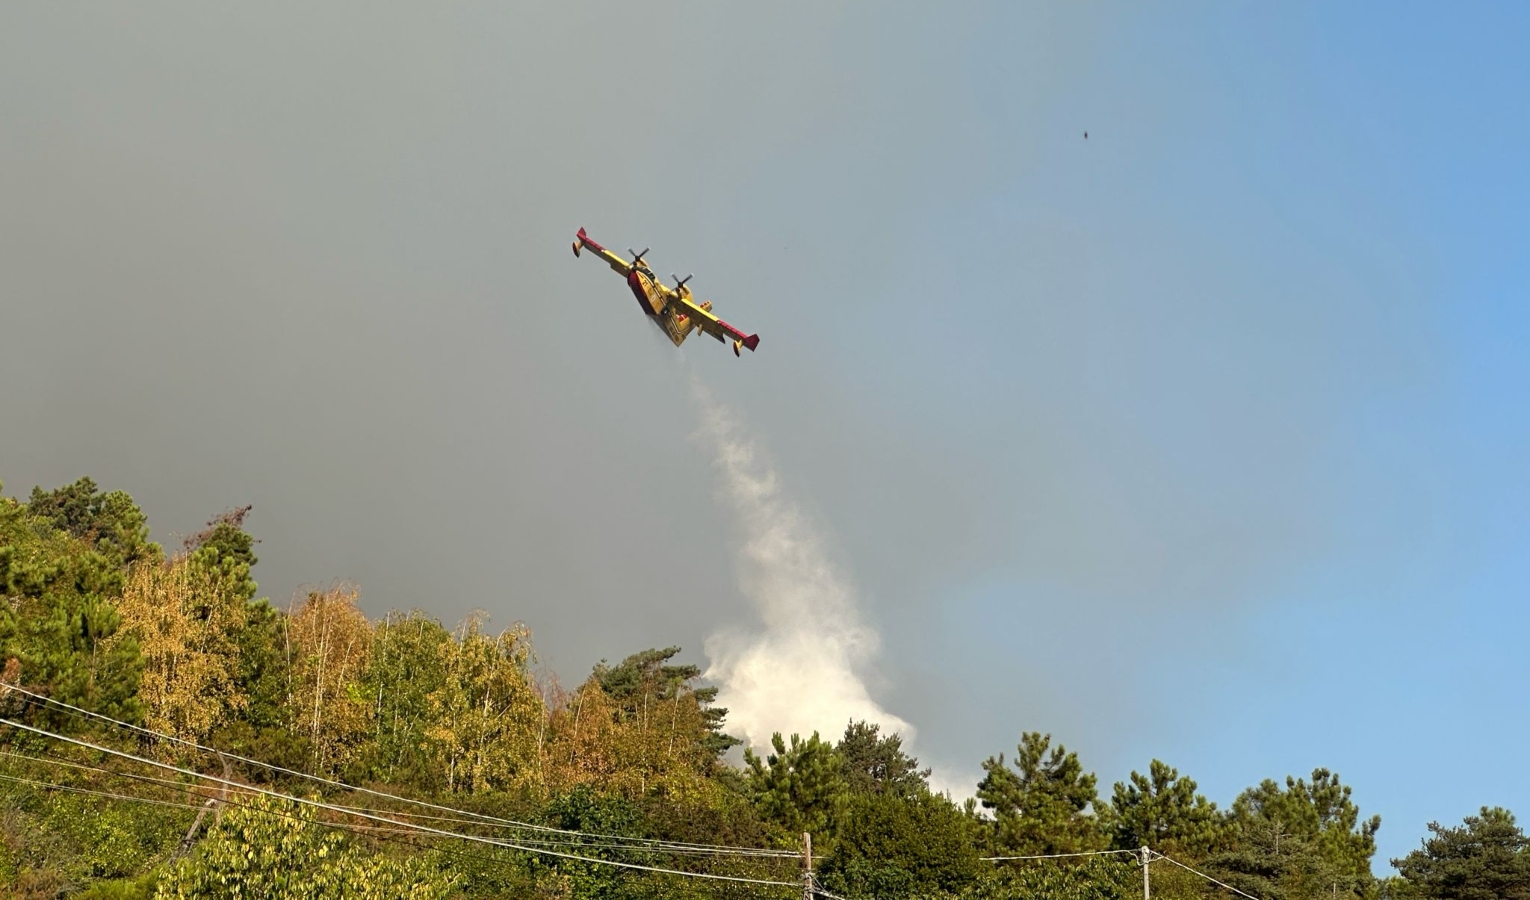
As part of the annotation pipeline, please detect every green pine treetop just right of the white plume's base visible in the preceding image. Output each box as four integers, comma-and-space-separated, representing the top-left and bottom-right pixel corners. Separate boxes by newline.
978, 732, 1105, 856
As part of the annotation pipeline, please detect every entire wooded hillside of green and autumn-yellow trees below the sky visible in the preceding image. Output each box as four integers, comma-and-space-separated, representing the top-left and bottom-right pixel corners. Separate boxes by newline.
0, 479, 1530, 900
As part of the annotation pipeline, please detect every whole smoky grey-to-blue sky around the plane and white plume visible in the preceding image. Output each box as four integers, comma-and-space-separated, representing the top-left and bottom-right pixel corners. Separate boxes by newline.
0, 2, 1530, 871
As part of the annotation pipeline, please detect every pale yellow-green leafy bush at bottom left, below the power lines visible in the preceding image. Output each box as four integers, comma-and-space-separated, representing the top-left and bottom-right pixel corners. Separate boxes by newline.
155, 797, 453, 900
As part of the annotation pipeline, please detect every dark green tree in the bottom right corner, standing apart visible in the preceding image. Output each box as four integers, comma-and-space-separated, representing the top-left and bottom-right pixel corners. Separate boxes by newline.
1392, 807, 1530, 900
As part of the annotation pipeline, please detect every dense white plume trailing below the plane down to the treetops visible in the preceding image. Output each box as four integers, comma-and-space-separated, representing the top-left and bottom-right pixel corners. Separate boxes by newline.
692, 381, 915, 748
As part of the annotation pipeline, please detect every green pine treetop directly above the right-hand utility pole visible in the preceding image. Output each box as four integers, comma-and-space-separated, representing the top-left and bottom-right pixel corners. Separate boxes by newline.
1111, 759, 1222, 859
